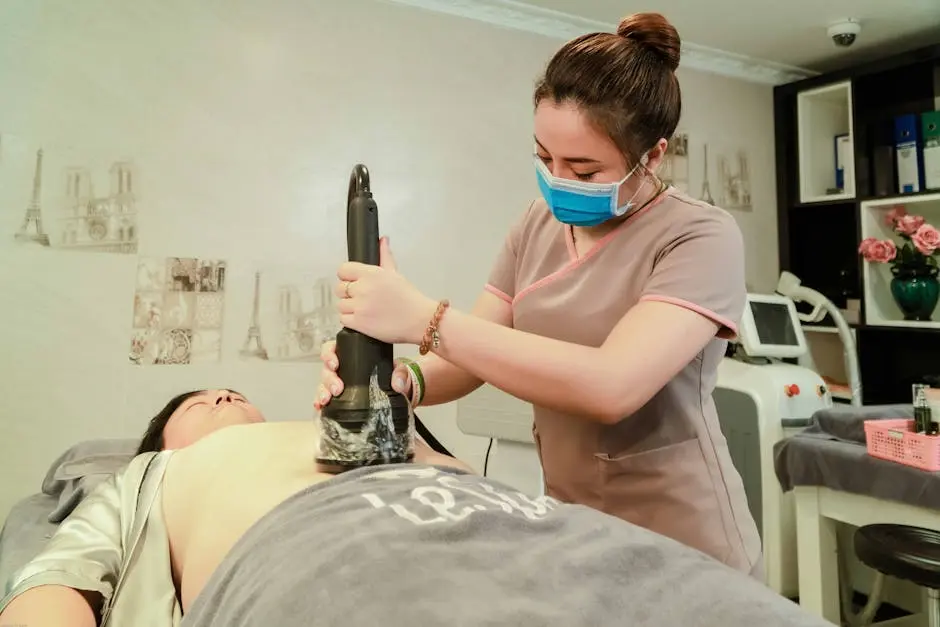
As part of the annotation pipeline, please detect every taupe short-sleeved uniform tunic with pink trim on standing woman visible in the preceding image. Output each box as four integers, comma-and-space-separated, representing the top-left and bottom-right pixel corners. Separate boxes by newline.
487, 188, 761, 575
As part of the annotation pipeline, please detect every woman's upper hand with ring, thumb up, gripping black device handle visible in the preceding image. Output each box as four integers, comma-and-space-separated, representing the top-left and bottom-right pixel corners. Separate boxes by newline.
334, 237, 437, 344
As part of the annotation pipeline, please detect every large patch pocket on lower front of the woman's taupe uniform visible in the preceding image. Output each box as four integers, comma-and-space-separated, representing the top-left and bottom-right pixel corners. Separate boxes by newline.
594, 438, 733, 562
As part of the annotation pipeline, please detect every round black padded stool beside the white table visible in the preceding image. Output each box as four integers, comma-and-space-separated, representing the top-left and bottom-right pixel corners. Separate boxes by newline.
855, 525, 940, 627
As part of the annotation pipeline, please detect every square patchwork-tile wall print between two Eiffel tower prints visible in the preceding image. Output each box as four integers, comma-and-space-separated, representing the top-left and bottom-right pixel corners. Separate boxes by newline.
130, 257, 226, 366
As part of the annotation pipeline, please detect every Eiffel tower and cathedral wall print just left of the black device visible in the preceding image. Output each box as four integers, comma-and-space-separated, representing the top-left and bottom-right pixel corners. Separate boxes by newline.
239, 269, 341, 362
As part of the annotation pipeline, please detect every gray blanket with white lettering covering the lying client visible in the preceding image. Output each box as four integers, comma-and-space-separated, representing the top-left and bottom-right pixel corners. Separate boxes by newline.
182, 465, 828, 627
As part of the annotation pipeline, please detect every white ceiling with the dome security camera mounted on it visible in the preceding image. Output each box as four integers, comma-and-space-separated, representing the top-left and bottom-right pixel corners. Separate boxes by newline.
519, 0, 940, 72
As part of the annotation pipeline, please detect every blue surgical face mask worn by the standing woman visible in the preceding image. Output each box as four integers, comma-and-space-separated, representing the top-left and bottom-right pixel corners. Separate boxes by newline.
535, 155, 647, 226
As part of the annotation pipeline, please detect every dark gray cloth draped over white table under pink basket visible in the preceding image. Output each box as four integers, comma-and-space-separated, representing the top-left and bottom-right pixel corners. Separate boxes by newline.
774, 405, 940, 509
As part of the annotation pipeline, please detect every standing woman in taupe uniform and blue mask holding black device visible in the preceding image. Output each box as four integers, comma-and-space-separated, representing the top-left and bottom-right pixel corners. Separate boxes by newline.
316, 13, 762, 578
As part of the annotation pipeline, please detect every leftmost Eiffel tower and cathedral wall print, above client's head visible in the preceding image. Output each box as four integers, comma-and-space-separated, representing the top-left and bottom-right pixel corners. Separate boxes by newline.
4, 148, 138, 254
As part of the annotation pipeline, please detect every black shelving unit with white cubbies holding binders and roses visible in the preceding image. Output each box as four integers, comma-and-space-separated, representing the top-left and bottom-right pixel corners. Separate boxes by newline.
774, 45, 940, 404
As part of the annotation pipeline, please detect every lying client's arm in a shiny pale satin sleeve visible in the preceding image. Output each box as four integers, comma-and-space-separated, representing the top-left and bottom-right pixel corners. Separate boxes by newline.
0, 458, 140, 627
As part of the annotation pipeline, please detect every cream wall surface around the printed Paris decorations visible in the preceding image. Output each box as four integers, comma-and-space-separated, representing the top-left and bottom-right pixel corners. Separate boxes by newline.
0, 0, 777, 516
